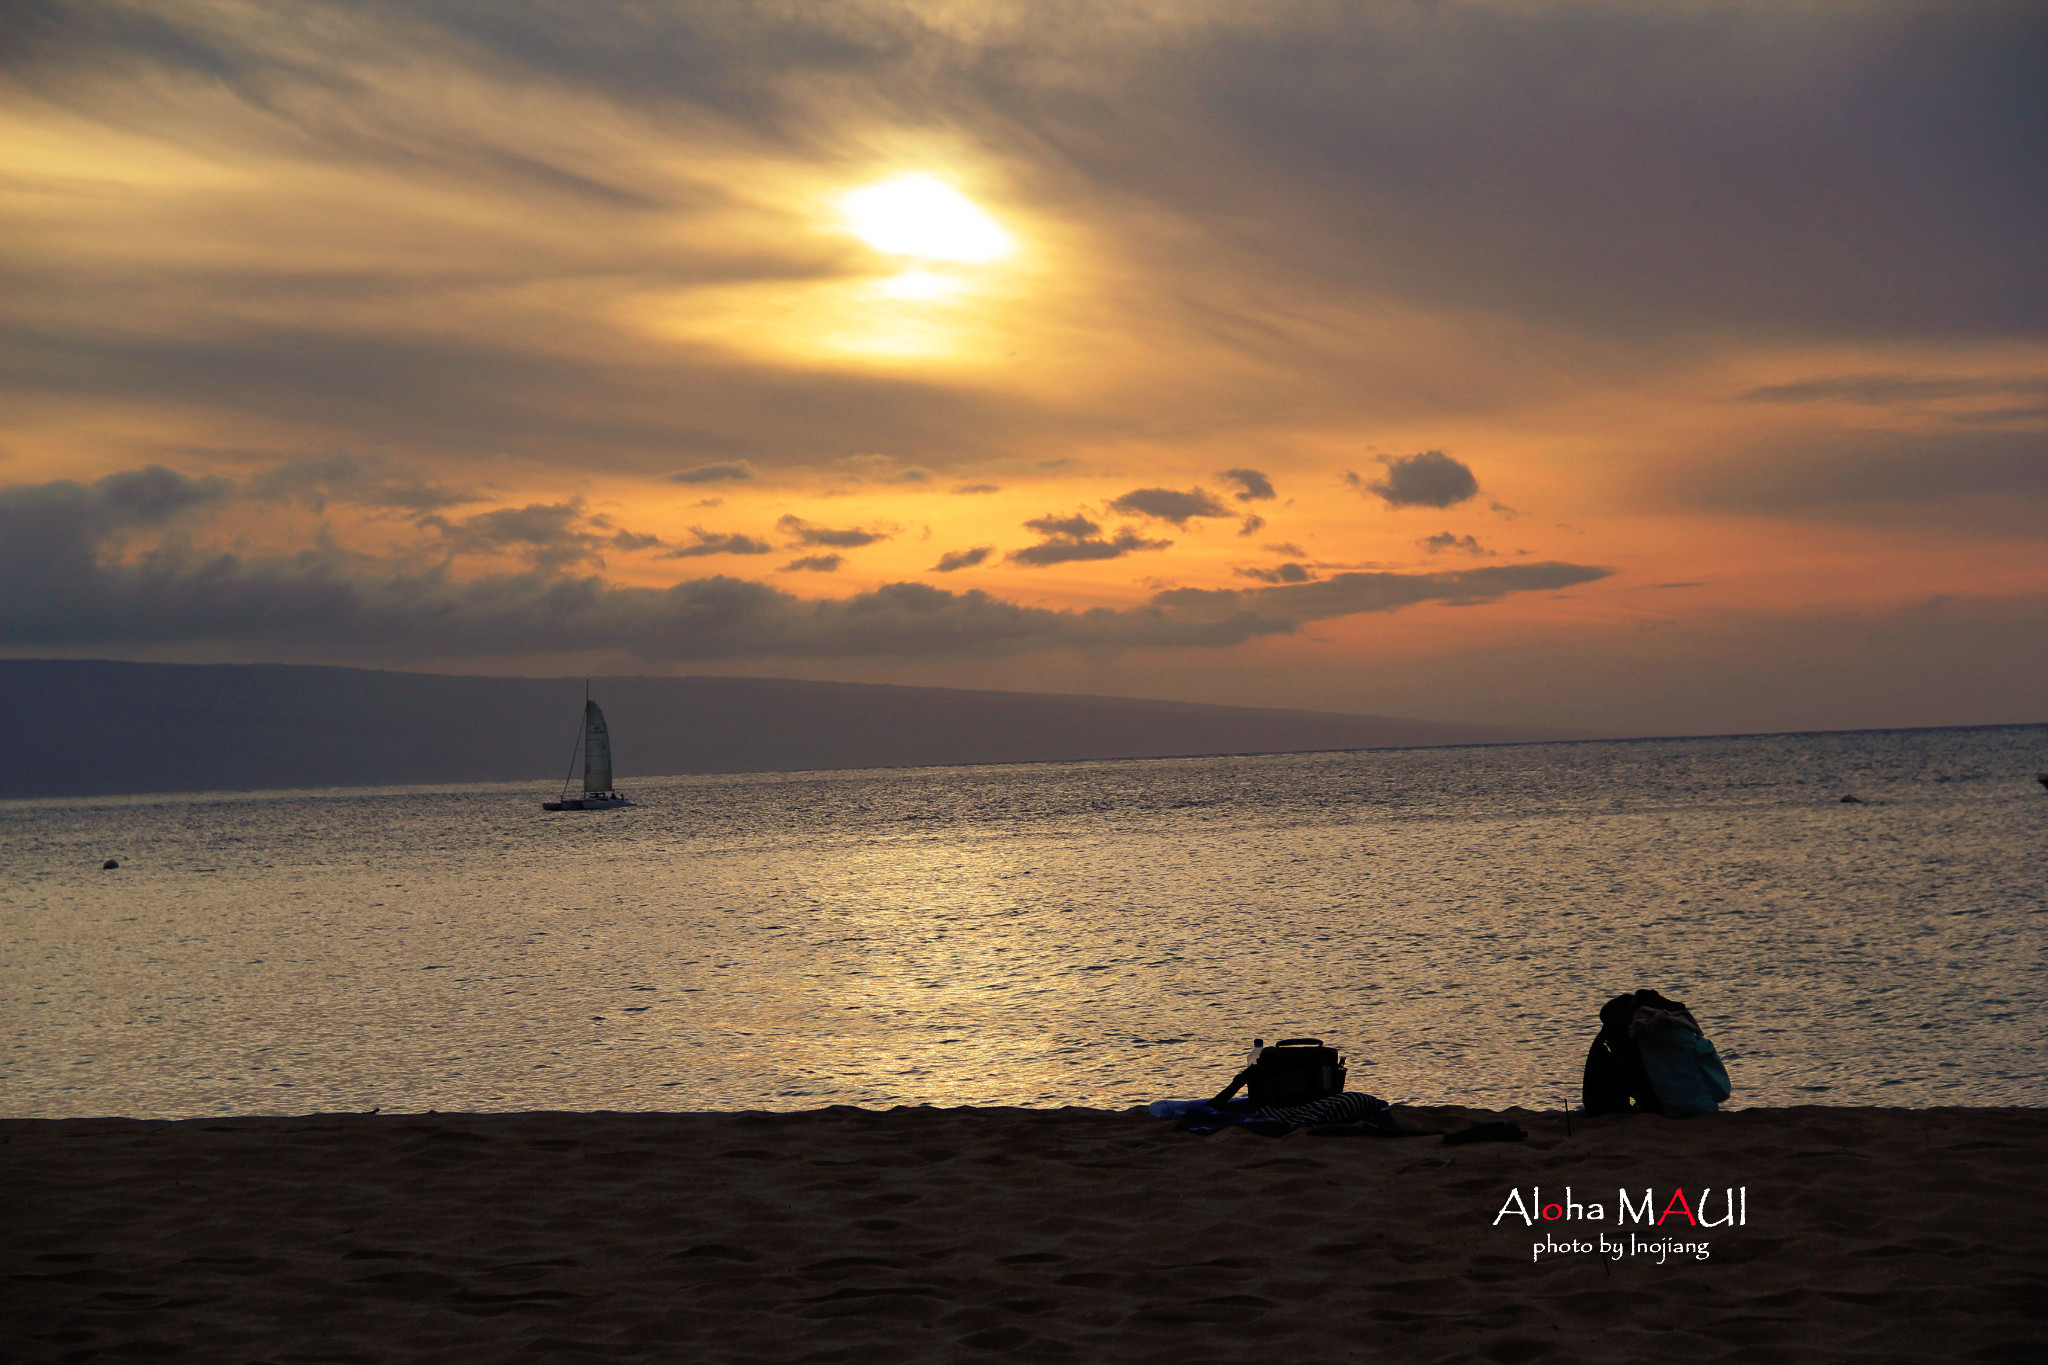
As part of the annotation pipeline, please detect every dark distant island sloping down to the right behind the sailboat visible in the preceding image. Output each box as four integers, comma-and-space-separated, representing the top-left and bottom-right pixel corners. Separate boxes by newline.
0, 659, 1583, 798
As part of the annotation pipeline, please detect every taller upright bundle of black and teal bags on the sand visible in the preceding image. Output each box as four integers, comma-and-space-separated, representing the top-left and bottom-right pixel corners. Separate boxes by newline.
1581, 990, 1731, 1119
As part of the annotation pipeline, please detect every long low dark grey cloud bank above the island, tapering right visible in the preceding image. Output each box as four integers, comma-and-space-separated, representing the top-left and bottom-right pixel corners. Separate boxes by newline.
0, 467, 1608, 661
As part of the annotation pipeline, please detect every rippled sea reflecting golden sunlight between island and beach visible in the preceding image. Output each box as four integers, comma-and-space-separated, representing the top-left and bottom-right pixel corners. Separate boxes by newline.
0, 726, 2048, 1117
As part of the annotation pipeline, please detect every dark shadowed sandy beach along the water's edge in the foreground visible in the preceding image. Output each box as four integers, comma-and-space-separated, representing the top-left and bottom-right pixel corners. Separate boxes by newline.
0, 1109, 2048, 1365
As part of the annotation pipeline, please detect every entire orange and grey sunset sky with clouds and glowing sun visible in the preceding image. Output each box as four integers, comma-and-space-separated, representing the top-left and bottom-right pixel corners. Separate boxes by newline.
0, 0, 2048, 735
